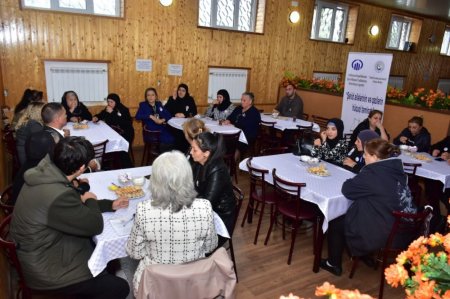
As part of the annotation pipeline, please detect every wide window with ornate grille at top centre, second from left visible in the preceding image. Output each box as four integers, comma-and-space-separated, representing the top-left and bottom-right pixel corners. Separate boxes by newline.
198, 0, 265, 33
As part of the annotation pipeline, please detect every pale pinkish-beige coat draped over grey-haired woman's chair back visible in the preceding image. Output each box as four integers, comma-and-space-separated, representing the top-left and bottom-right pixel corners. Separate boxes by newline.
136, 247, 236, 299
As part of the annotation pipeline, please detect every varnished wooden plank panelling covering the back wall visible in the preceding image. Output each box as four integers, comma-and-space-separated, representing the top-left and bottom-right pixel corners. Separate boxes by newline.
0, 0, 450, 118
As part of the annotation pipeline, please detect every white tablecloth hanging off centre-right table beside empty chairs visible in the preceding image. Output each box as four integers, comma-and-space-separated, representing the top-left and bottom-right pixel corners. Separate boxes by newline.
239, 154, 355, 232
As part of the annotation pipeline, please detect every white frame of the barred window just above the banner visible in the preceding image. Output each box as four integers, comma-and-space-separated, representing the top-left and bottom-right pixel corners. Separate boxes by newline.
310, 0, 350, 43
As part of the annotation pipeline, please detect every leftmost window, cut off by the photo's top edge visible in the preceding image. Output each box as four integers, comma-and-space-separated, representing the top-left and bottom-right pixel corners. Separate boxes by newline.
21, 0, 124, 17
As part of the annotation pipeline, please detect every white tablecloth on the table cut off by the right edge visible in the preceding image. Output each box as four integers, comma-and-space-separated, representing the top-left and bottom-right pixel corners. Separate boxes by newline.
399, 153, 450, 189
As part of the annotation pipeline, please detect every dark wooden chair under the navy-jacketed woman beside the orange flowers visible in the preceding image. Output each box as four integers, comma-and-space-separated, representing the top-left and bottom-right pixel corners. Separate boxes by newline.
349, 208, 432, 299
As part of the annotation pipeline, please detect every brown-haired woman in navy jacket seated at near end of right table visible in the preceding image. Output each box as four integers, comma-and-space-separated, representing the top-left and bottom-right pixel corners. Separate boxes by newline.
320, 139, 416, 276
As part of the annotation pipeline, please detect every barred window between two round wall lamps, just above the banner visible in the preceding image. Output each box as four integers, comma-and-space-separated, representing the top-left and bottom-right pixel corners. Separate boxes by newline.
311, 0, 349, 43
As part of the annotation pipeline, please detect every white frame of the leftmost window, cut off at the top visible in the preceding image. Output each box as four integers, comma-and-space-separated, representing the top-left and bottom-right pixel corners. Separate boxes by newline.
20, 0, 125, 18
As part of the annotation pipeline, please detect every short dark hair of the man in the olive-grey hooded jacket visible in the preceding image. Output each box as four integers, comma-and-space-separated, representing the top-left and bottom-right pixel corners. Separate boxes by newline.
53, 136, 95, 175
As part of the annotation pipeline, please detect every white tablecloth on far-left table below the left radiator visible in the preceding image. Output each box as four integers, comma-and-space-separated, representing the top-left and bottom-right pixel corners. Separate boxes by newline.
66, 121, 129, 153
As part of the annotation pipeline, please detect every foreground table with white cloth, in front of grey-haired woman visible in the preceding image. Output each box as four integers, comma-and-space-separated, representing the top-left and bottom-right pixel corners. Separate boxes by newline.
80, 166, 230, 276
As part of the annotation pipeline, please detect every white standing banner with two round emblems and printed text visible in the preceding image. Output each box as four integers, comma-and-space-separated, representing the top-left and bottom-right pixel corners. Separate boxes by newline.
341, 52, 392, 133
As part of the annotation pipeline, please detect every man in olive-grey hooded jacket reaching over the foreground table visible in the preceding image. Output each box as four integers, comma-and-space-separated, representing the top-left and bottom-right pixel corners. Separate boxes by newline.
11, 137, 129, 298
